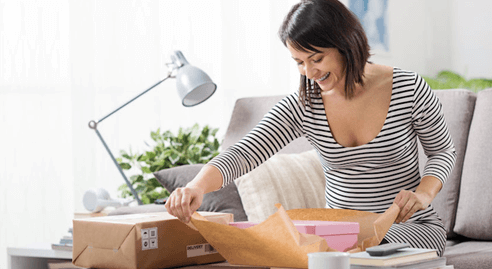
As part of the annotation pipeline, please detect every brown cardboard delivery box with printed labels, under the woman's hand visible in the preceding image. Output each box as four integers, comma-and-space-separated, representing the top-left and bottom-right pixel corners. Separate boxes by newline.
73, 212, 234, 269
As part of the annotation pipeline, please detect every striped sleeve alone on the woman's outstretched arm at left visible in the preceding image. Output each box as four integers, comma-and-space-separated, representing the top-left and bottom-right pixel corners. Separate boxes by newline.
208, 93, 304, 187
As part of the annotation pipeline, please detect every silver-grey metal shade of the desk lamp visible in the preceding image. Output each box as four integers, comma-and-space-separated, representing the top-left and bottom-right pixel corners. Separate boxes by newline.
171, 51, 217, 107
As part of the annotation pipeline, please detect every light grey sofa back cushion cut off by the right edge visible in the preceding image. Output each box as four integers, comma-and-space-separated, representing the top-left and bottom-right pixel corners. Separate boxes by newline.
454, 89, 492, 240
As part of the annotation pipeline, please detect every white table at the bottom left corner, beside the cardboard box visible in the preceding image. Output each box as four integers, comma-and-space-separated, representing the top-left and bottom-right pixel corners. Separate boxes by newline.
7, 243, 72, 269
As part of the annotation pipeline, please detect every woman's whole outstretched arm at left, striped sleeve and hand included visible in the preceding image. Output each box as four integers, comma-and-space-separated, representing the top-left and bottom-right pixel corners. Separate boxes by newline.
166, 94, 303, 223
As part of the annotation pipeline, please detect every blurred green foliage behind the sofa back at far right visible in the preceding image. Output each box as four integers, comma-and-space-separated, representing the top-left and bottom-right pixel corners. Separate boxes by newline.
424, 70, 492, 92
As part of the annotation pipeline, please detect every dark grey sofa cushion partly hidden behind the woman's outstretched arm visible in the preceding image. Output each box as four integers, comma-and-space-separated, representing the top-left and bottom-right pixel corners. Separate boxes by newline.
154, 164, 247, 221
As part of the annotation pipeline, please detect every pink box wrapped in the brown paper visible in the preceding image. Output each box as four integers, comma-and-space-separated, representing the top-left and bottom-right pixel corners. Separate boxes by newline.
229, 220, 359, 252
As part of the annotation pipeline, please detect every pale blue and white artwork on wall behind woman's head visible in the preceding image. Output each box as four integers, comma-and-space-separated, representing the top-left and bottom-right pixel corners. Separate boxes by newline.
349, 0, 389, 51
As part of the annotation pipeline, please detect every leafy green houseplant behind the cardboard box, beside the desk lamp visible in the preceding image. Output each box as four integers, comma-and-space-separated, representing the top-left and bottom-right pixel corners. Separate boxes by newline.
116, 124, 220, 204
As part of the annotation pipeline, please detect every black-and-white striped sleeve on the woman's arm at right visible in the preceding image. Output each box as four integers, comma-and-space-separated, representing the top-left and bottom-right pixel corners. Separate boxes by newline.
412, 74, 456, 184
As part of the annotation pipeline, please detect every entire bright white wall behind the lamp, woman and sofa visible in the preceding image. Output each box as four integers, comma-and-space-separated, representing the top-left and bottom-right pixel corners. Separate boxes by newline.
0, 0, 492, 268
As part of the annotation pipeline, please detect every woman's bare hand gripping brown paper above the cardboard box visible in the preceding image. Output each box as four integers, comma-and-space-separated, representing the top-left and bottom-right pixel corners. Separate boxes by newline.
165, 186, 204, 223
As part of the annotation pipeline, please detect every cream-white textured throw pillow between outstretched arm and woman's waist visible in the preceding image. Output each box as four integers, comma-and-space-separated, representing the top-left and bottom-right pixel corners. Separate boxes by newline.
235, 150, 325, 222
